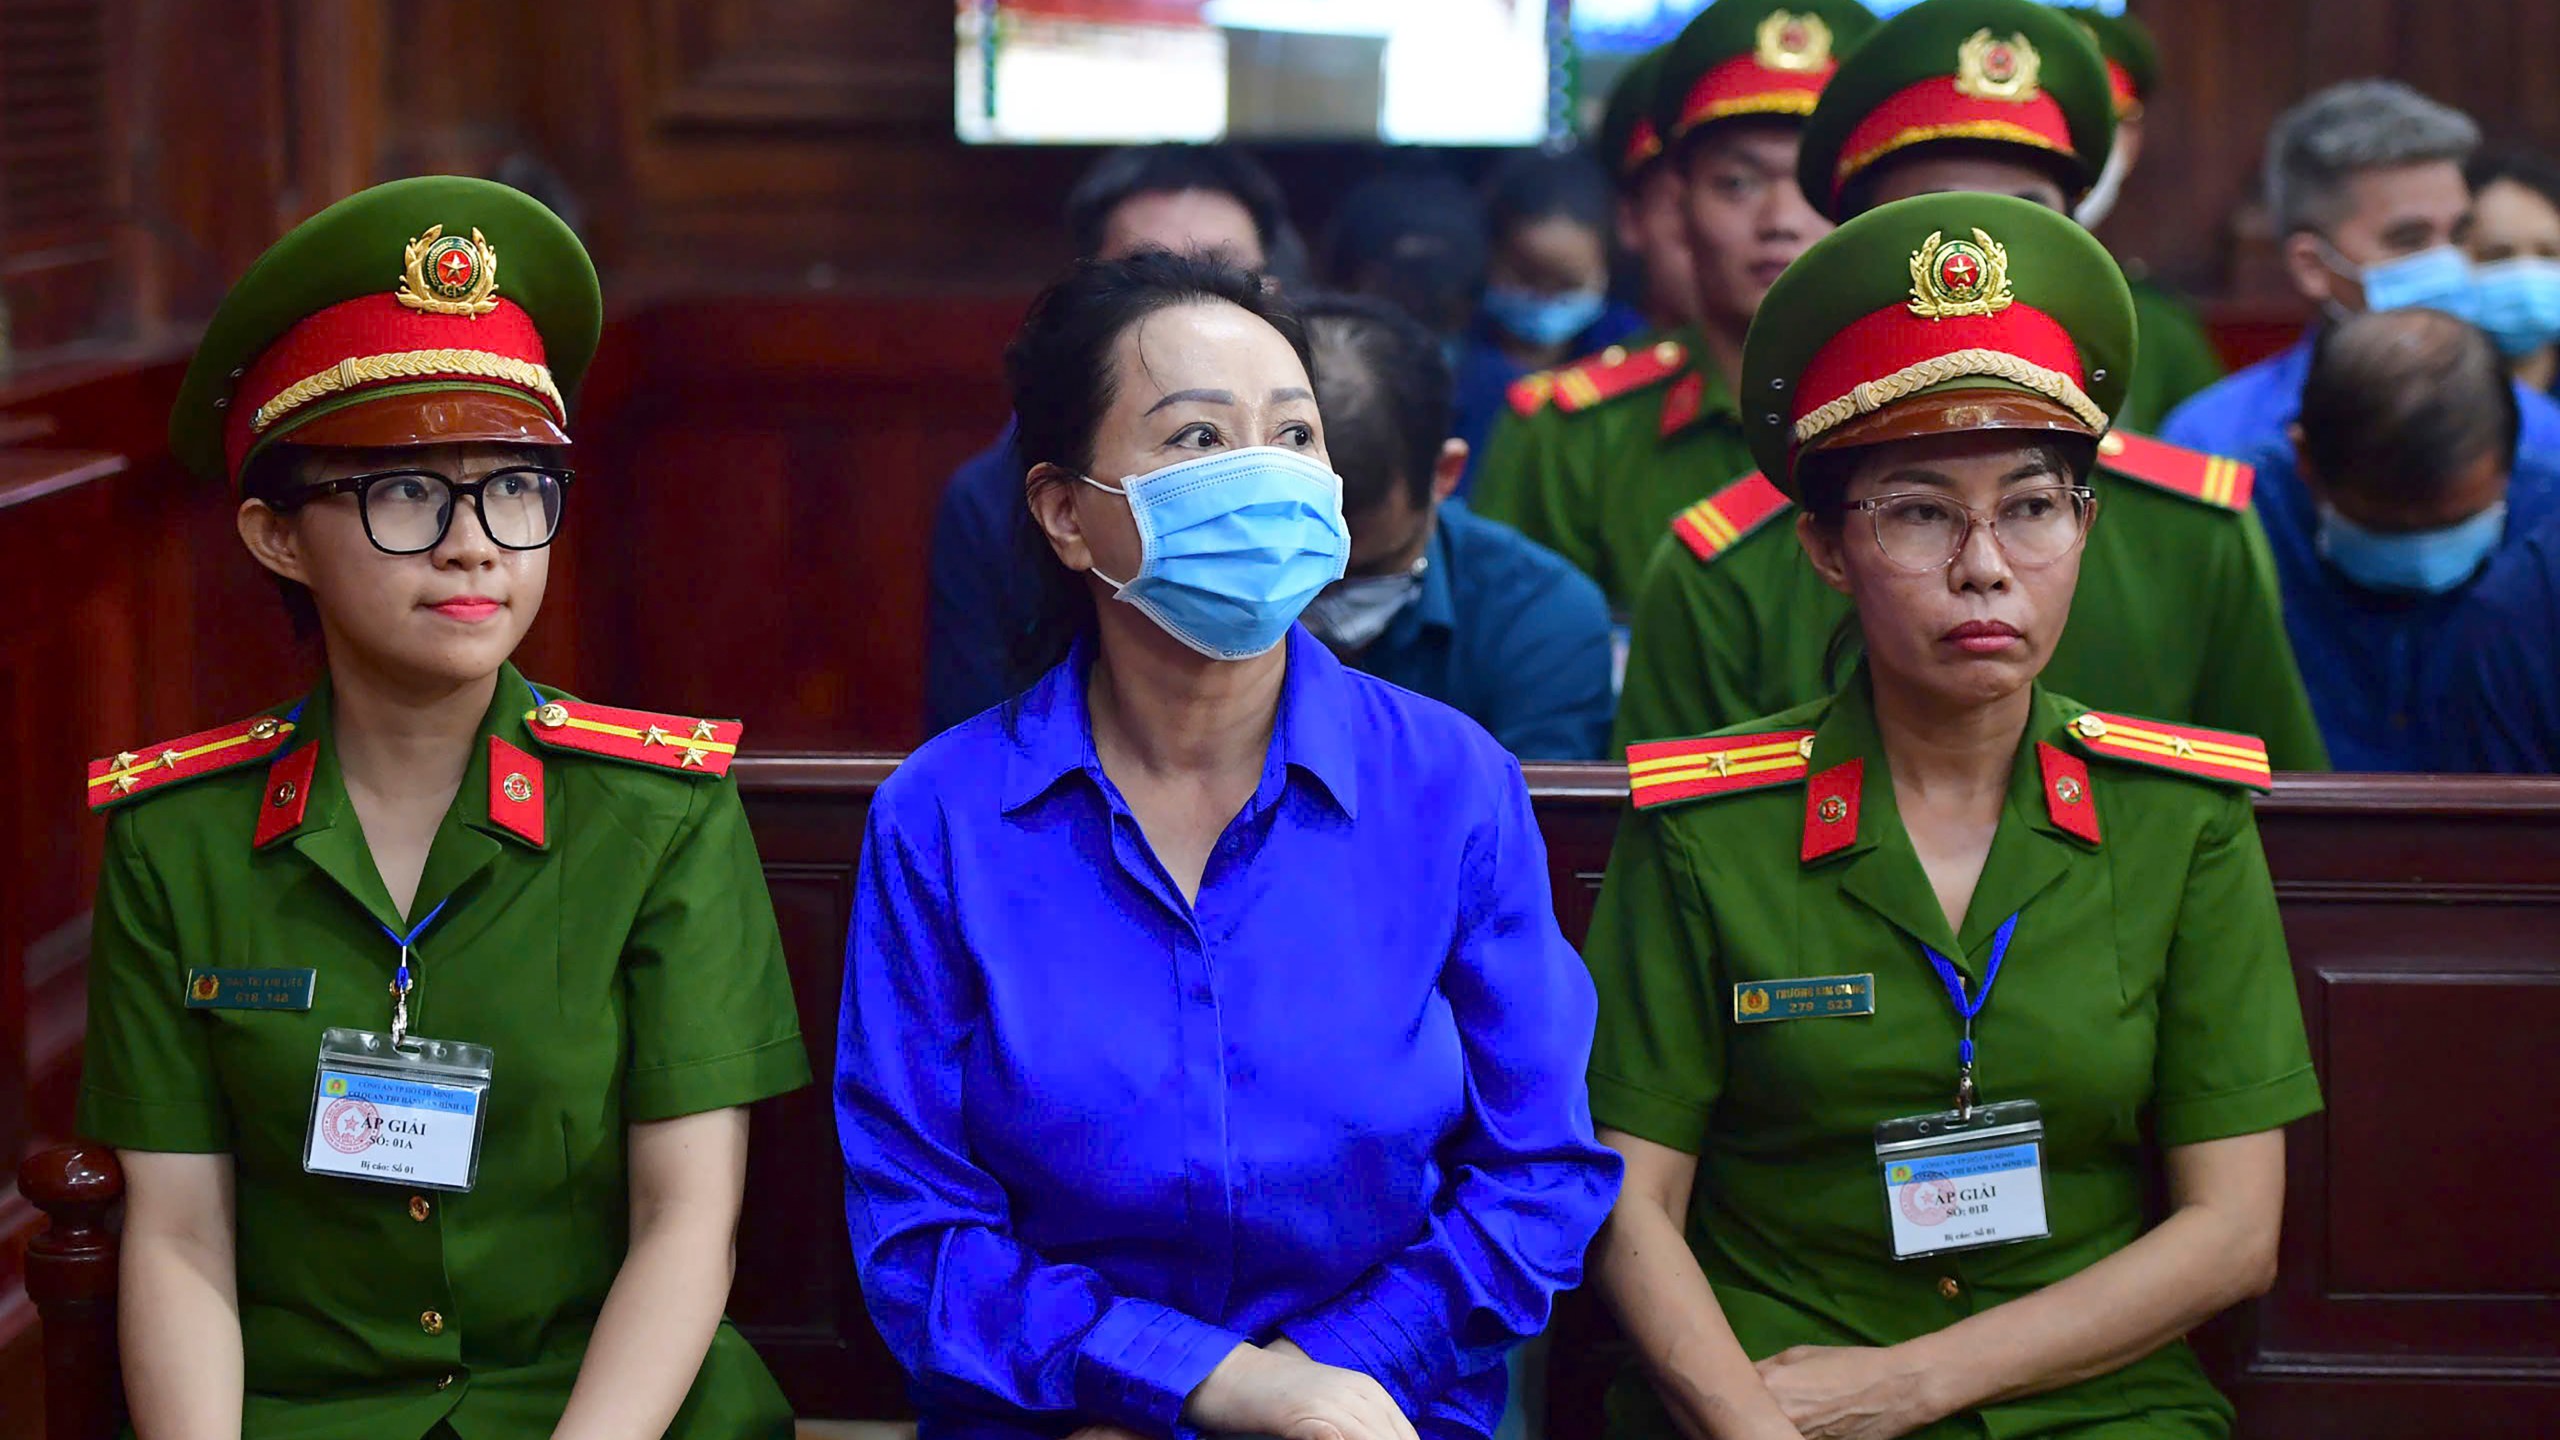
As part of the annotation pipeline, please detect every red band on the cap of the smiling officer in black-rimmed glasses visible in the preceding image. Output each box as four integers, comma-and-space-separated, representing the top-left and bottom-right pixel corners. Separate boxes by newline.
223, 292, 568, 474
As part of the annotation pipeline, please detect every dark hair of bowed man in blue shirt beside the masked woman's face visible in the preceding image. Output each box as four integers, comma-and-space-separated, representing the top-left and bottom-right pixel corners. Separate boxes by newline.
1298, 295, 1457, 515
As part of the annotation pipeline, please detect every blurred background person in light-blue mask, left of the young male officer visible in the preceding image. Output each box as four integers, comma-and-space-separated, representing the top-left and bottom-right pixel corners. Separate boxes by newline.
1457, 151, 1644, 479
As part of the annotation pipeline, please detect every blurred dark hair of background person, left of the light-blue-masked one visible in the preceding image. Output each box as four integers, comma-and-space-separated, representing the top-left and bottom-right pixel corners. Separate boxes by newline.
1324, 159, 1485, 336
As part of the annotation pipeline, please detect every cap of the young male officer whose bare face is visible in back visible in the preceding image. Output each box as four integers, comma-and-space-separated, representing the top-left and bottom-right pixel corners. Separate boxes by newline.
1654, 0, 1876, 146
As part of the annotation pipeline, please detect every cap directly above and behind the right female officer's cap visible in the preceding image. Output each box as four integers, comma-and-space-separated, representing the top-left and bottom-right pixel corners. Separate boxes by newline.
1797, 0, 2115, 220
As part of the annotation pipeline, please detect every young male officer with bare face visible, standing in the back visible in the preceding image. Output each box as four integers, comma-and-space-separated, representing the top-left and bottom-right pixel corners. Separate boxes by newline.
1469, 0, 1874, 615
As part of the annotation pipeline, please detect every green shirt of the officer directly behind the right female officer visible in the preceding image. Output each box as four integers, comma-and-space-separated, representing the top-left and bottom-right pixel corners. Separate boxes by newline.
1618, 464, 2330, 771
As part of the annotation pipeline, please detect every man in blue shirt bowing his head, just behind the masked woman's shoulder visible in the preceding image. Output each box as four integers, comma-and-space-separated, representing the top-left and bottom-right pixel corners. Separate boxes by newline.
1300, 297, 1615, 761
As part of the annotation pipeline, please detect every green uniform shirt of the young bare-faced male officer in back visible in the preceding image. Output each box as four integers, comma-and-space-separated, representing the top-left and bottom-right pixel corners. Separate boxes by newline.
1467, 331, 1751, 615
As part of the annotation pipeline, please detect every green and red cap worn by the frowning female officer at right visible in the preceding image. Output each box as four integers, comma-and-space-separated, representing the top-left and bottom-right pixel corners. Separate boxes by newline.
1741, 195, 2132, 497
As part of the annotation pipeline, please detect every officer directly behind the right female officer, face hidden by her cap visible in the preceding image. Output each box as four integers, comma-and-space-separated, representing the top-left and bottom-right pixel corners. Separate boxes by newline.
1618, 0, 2327, 769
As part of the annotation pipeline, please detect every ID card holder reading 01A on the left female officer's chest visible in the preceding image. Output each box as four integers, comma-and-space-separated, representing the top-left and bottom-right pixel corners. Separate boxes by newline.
302, 1030, 494, 1191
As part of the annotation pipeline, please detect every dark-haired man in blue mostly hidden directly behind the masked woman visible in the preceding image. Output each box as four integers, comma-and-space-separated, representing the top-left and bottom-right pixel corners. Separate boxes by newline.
924, 146, 1306, 735
